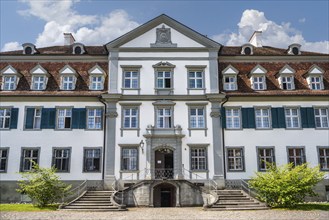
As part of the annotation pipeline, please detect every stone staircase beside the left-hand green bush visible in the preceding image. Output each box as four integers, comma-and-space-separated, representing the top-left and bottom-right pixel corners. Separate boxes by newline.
61, 191, 126, 212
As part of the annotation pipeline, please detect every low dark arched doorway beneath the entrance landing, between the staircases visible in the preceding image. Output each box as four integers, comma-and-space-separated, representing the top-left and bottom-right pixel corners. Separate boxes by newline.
153, 183, 176, 207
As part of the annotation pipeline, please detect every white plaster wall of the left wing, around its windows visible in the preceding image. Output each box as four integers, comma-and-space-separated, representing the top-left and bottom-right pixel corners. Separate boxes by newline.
0, 100, 103, 180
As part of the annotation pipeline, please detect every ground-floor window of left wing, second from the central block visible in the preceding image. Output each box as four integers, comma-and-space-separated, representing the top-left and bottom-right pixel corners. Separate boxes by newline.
52, 149, 70, 172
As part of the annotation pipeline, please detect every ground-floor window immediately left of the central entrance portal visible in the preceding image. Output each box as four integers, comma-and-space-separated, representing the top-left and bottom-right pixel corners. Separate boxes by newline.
121, 148, 138, 171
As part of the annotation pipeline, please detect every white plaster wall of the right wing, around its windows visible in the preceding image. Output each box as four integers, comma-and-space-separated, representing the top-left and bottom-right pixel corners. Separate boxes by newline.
224, 101, 329, 179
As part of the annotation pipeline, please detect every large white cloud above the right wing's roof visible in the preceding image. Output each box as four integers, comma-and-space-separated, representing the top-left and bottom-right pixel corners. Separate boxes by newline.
212, 9, 329, 53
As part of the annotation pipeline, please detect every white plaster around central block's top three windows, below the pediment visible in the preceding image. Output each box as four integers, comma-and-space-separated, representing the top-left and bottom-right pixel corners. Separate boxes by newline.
118, 60, 210, 95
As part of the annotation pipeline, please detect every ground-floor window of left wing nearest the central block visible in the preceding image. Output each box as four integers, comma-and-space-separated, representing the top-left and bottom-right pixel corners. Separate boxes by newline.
83, 148, 101, 172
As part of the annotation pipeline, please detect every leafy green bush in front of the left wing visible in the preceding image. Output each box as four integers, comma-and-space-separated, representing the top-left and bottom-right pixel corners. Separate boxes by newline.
17, 162, 71, 207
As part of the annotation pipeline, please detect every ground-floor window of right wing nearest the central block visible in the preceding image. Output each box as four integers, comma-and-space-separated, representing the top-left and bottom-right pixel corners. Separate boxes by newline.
227, 148, 244, 171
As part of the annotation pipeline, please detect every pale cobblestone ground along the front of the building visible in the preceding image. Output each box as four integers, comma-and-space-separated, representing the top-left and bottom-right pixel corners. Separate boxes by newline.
0, 207, 329, 220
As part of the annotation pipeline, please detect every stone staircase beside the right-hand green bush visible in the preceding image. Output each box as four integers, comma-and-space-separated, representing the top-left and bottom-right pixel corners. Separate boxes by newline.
206, 190, 269, 211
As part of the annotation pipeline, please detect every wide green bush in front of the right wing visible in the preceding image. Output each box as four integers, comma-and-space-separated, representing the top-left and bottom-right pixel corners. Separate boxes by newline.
249, 163, 324, 207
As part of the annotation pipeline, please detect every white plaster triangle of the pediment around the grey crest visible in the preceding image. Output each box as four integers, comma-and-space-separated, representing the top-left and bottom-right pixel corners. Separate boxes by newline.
121, 24, 204, 47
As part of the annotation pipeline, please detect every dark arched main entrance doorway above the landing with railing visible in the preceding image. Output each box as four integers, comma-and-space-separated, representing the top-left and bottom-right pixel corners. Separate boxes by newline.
154, 148, 174, 179
